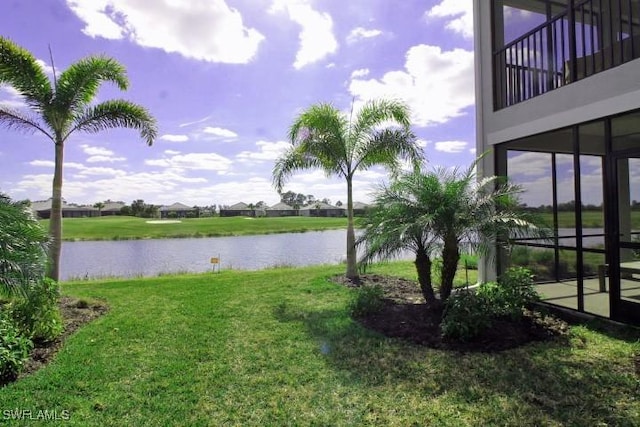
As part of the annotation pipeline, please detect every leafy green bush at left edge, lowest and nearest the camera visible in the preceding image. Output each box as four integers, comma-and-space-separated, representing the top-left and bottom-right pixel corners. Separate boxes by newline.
0, 312, 33, 384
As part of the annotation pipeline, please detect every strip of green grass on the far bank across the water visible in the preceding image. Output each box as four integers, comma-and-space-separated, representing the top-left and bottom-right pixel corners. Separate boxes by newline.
41, 216, 347, 240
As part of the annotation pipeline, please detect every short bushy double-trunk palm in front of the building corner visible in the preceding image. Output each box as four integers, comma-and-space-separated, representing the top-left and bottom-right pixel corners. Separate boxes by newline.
359, 159, 548, 303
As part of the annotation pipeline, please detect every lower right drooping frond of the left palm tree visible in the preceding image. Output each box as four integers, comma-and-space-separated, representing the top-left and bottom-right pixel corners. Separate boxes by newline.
63, 100, 158, 145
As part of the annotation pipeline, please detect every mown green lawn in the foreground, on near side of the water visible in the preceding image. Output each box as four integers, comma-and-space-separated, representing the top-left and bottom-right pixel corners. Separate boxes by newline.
0, 263, 640, 427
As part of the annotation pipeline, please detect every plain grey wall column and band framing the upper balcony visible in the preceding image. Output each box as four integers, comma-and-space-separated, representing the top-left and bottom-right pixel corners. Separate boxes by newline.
474, 0, 640, 153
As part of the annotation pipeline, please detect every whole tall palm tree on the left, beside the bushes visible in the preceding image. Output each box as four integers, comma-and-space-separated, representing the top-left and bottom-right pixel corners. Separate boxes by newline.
0, 37, 157, 280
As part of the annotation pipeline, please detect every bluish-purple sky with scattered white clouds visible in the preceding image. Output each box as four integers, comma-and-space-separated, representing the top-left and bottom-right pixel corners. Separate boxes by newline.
0, 0, 475, 206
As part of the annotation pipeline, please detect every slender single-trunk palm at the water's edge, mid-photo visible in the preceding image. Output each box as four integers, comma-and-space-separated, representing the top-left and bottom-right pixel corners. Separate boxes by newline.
273, 99, 422, 281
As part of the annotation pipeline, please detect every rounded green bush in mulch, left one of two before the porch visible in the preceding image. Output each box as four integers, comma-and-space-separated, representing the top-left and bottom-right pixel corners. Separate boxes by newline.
440, 289, 491, 341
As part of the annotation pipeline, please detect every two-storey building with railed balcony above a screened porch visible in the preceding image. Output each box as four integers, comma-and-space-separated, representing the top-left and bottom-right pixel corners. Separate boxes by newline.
473, 0, 640, 324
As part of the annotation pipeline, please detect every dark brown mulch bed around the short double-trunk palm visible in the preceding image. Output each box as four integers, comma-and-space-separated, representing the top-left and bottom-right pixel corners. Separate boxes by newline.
332, 274, 569, 352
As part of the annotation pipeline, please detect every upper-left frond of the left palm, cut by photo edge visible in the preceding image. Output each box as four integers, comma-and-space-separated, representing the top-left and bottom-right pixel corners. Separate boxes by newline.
0, 37, 53, 111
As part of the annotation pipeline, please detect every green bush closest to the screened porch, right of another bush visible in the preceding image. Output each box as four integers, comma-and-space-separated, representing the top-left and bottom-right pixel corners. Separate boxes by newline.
477, 267, 540, 319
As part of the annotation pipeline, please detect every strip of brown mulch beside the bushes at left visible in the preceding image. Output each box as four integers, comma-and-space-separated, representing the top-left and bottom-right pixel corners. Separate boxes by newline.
18, 297, 109, 378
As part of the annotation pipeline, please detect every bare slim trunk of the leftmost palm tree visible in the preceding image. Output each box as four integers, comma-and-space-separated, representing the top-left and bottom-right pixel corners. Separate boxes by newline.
47, 140, 64, 281
